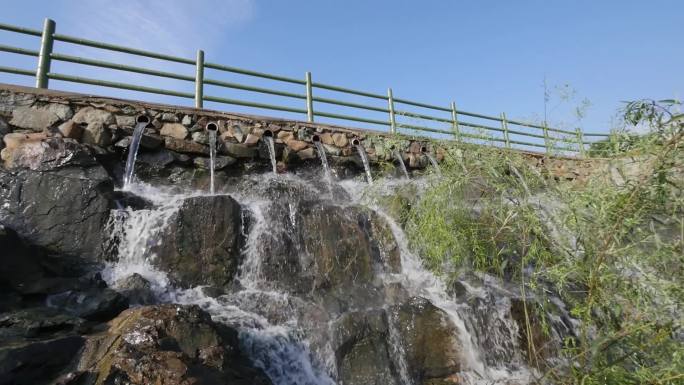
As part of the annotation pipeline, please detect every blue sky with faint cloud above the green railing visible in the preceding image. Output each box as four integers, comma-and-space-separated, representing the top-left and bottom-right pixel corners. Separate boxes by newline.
0, 0, 684, 141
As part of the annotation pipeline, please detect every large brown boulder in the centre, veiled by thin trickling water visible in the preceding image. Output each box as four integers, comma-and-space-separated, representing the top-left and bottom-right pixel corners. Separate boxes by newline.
258, 198, 401, 305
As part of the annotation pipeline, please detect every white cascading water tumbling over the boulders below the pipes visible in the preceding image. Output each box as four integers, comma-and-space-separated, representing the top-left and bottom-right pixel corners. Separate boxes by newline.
104, 170, 556, 385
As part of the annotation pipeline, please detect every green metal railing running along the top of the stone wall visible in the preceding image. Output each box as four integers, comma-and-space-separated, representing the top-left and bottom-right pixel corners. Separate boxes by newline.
0, 19, 609, 155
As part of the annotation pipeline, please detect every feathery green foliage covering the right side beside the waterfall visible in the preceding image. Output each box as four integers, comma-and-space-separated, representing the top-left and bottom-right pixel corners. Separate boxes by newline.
372, 101, 684, 385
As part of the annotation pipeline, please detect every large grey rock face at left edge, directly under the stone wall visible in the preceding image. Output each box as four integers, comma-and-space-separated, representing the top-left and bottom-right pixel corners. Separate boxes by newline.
0, 160, 113, 261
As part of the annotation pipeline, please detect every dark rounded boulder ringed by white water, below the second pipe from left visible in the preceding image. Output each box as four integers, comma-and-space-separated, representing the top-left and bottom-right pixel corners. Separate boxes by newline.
153, 195, 242, 287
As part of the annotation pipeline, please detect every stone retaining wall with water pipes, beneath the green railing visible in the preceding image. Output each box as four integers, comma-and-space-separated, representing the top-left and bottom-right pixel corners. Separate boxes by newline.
0, 84, 616, 180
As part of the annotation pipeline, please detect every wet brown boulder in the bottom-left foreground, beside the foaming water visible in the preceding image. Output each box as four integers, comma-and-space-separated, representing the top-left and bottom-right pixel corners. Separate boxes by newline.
77, 305, 271, 385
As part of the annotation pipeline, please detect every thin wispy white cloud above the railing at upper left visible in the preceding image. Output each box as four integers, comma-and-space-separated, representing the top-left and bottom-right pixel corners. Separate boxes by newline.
59, 0, 254, 57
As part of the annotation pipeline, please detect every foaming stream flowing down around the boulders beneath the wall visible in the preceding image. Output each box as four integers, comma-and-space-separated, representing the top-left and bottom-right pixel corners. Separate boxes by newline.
103, 173, 560, 385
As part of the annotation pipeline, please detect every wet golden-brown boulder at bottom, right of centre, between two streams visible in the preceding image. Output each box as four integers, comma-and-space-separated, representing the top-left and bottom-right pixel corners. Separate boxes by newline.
389, 297, 461, 383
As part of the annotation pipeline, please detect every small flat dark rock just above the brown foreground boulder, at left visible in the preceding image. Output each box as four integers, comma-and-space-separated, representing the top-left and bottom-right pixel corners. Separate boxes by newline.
48, 288, 128, 321
